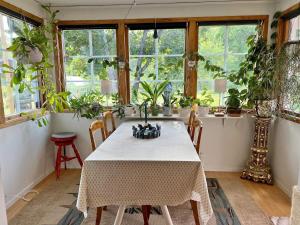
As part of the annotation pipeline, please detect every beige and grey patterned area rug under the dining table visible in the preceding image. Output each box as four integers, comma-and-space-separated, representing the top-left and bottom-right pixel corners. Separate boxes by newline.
9, 171, 272, 225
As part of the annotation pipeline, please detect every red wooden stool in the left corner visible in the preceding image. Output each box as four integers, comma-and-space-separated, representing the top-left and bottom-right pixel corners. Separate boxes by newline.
51, 132, 82, 179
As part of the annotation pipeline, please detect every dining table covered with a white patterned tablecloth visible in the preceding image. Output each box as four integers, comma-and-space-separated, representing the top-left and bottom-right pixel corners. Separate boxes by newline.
76, 120, 213, 225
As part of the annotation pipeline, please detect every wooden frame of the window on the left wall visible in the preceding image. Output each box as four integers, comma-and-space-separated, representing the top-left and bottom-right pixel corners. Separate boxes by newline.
0, 0, 44, 128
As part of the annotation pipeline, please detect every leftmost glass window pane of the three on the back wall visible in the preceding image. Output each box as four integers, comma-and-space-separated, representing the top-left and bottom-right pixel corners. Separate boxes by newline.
62, 29, 117, 97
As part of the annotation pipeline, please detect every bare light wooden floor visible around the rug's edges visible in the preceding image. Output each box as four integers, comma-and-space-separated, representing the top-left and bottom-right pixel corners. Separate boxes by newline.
7, 169, 291, 221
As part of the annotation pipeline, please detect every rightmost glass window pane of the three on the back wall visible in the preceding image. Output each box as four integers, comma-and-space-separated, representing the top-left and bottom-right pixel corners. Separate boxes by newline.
197, 24, 257, 106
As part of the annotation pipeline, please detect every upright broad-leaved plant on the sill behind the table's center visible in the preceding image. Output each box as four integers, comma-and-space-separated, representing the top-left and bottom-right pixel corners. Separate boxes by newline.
141, 80, 169, 116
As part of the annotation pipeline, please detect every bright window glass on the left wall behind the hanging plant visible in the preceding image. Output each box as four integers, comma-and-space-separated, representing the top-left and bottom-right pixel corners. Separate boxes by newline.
0, 13, 40, 117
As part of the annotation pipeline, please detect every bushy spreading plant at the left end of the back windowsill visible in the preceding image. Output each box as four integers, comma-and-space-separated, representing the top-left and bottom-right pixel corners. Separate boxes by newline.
69, 91, 104, 119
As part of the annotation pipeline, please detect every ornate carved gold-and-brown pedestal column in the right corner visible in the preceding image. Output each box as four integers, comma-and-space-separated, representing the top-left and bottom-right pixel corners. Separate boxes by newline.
241, 117, 272, 184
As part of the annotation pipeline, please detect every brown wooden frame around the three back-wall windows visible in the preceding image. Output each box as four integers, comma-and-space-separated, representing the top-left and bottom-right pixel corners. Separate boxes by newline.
55, 15, 269, 104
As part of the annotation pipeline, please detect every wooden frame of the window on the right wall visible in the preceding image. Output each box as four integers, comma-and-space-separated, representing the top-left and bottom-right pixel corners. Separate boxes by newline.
276, 3, 300, 123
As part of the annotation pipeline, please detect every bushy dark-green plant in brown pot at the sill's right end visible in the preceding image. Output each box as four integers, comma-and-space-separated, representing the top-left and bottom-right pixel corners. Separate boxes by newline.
225, 88, 242, 117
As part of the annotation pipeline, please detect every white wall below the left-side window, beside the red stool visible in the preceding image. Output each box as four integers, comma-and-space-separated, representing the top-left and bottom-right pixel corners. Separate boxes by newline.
0, 117, 54, 207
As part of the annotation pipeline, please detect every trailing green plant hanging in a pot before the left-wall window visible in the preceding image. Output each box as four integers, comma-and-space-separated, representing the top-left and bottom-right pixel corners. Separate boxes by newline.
2, 6, 70, 127
